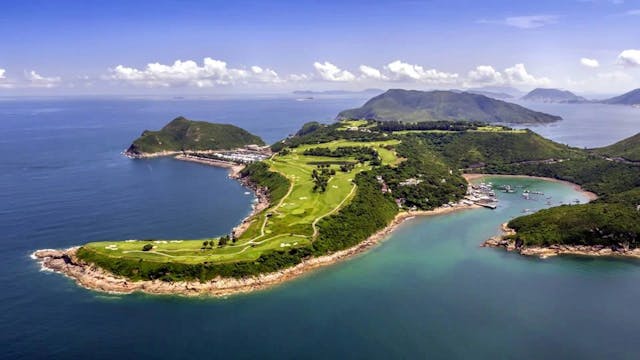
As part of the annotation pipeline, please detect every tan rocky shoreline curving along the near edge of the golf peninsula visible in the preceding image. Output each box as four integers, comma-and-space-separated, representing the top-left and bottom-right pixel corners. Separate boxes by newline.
32, 205, 479, 296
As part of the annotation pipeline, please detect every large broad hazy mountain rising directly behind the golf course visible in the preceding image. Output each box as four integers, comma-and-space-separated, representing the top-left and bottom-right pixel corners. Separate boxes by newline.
337, 89, 562, 124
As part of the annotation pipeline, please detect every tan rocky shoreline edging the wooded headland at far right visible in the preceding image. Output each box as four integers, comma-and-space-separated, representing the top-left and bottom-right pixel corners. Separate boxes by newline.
481, 223, 640, 259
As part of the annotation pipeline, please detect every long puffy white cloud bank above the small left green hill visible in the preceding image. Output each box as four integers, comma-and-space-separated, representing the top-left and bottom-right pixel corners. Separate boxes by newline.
110, 57, 282, 87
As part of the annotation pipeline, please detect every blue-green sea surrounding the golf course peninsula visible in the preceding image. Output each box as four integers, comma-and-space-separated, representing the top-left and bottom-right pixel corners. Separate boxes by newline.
0, 97, 640, 359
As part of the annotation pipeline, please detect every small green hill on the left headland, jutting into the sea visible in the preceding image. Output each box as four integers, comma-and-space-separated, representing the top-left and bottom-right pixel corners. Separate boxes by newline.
125, 116, 264, 157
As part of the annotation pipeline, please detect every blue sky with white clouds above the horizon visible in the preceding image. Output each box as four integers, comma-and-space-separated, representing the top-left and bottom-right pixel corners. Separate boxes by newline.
0, 0, 640, 95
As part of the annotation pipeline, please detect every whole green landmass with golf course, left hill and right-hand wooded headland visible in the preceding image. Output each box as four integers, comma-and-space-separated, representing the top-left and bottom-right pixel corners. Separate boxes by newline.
33, 95, 640, 295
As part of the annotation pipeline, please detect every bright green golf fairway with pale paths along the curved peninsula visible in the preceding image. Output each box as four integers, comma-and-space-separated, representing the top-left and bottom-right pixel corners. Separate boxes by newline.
85, 140, 401, 264
